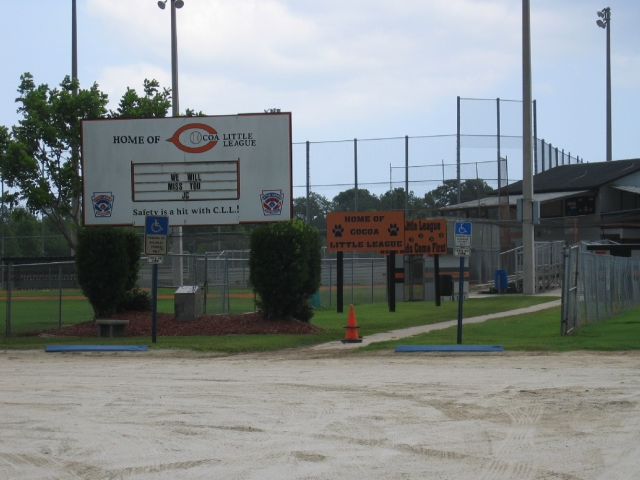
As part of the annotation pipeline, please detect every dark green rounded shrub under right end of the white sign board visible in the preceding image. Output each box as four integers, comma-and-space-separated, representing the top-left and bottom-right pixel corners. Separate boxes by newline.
249, 220, 321, 322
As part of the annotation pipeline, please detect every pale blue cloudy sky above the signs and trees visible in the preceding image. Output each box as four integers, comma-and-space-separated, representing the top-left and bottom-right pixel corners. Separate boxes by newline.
0, 0, 640, 197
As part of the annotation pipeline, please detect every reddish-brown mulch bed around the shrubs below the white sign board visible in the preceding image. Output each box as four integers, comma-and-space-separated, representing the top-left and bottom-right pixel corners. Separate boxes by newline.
29, 312, 322, 337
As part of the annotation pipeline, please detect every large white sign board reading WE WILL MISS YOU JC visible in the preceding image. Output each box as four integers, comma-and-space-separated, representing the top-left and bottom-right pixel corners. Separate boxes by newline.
82, 113, 293, 226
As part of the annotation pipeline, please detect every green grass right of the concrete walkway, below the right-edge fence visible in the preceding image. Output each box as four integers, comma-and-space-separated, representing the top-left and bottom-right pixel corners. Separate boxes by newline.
358, 307, 640, 352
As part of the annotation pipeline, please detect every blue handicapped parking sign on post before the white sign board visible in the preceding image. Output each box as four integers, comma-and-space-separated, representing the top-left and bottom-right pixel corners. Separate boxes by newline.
144, 216, 169, 343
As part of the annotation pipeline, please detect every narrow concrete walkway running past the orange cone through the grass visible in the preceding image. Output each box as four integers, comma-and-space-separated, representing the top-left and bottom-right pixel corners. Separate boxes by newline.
311, 299, 561, 350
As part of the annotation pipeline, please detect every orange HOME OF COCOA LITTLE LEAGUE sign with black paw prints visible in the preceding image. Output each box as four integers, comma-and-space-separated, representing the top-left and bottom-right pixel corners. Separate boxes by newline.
327, 212, 404, 252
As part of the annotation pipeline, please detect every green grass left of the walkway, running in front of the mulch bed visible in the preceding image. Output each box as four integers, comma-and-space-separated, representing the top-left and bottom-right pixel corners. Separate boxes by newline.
0, 295, 560, 352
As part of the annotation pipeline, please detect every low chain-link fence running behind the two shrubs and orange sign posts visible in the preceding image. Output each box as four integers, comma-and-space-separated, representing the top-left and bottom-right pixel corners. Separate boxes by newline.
0, 250, 387, 336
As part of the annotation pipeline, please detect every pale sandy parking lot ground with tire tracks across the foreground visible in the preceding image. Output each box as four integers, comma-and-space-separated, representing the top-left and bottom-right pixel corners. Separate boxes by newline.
0, 349, 640, 480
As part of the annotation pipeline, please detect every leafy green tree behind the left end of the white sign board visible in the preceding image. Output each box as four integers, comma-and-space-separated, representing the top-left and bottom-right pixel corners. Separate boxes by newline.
0, 73, 178, 249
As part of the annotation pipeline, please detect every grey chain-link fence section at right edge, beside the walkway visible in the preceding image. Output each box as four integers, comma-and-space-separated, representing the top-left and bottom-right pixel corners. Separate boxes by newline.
561, 246, 640, 335
